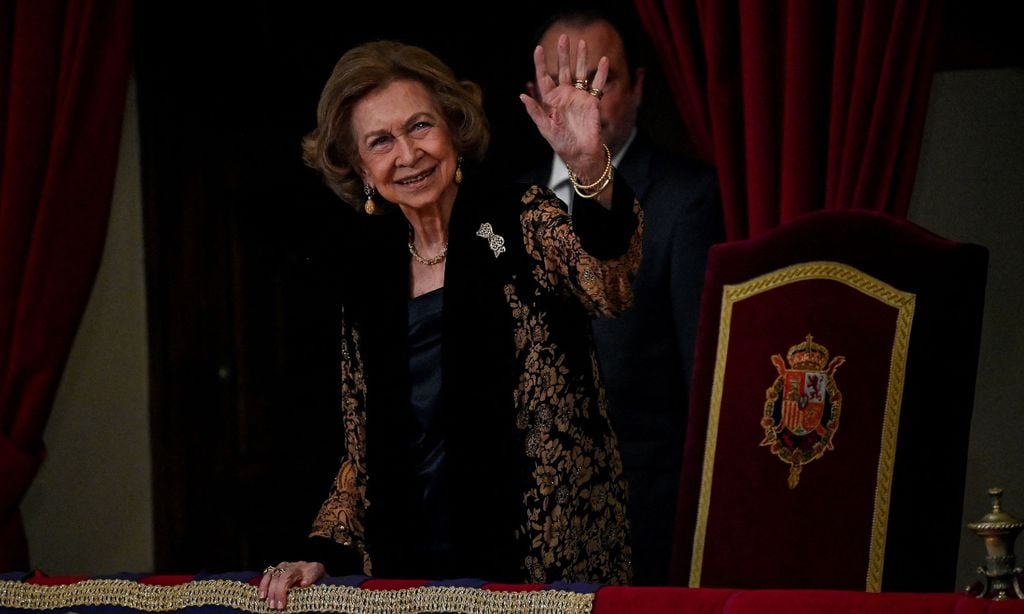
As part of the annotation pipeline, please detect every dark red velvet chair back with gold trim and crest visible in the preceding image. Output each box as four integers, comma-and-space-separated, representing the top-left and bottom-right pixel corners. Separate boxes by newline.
672, 211, 988, 591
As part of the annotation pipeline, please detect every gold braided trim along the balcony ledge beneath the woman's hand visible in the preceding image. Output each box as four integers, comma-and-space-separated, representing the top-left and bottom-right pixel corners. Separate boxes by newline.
0, 580, 594, 614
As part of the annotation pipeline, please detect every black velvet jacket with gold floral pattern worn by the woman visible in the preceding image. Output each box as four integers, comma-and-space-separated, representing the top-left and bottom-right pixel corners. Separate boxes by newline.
311, 174, 642, 583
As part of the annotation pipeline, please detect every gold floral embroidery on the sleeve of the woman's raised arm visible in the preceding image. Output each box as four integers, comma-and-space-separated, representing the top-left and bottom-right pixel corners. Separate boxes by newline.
522, 185, 643, 317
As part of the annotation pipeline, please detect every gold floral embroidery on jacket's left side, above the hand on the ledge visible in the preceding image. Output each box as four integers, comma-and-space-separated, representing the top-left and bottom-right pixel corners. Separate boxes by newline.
310, 311, 373, 575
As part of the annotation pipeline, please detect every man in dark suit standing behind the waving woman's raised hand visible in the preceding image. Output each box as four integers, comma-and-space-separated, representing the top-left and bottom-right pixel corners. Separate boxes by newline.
527, 9, 723, 584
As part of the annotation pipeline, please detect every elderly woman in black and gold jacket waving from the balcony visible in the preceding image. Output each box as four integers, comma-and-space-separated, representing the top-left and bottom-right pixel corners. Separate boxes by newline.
259, 37, 641, 608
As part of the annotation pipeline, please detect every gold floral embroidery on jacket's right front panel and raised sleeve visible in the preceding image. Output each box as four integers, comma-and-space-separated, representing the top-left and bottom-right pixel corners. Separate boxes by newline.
505, 191, 639, 583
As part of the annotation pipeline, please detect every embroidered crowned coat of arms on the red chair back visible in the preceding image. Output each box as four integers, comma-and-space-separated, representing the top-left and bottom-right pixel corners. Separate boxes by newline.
761, 335, 846, 489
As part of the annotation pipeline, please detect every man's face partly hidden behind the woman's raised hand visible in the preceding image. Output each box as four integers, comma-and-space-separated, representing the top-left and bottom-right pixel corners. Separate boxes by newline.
541, 21, 643, 155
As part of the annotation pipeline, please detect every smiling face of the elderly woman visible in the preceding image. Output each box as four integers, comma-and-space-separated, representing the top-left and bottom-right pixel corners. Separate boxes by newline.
352, 81, 458, 213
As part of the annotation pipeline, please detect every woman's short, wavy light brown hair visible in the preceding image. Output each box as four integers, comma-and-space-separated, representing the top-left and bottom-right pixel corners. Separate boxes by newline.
302, 41, 490, 208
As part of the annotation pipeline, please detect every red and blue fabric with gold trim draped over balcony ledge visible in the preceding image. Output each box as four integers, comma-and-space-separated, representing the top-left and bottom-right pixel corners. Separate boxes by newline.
6, 572, 1024, 614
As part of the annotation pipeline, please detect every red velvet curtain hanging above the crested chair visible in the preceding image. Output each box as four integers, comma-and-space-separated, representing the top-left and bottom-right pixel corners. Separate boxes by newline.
634, 0, 940, 239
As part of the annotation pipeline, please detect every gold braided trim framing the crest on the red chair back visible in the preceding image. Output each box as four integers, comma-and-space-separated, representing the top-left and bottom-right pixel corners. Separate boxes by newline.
689, 261, 916, 593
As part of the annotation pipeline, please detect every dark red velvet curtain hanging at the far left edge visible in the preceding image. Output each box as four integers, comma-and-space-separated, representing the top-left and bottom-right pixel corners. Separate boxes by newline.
0, 0, 132, 571
